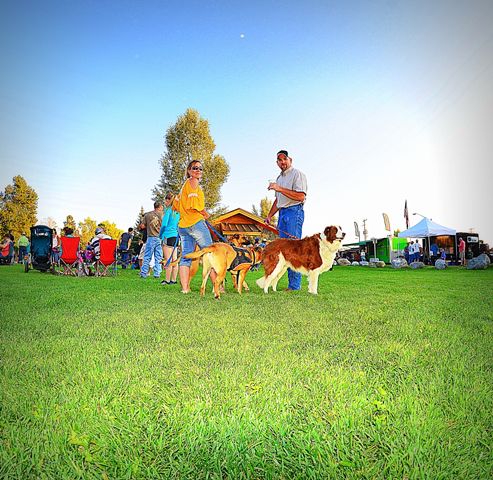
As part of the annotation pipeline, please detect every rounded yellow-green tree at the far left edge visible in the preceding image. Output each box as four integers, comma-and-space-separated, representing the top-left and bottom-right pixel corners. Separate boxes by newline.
0, 175, 38, 238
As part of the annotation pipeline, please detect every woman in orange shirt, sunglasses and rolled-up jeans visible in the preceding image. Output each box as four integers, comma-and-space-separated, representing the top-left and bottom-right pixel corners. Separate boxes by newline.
176, 160, 216, 293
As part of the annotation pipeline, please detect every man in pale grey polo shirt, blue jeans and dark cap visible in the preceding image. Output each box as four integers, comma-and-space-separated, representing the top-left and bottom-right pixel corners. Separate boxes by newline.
265, 150, 307, 290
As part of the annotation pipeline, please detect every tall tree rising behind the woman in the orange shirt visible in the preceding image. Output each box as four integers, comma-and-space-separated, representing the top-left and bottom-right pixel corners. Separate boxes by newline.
152, 108, 229, 215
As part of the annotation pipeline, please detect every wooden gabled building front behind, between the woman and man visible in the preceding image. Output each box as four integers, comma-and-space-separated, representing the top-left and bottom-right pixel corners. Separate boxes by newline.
211, 208, 278, 243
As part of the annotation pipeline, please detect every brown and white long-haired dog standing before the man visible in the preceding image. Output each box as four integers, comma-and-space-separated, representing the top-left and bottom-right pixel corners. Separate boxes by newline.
257, 226, 346, 295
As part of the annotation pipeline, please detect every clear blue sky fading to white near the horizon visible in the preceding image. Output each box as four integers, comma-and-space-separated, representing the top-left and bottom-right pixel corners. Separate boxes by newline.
0, 0, 493, 243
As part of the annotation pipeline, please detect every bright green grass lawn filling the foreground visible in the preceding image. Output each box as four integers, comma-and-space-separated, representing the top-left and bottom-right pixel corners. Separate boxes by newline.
0, 266, 493, 479
